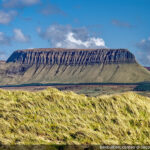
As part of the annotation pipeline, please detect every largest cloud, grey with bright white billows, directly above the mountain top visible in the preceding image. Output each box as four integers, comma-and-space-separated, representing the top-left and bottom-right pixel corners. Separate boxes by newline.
37, 25, 105, 48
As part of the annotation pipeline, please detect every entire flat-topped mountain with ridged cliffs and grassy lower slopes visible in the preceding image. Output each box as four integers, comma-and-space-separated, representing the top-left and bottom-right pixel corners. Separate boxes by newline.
0, 48, 150, 85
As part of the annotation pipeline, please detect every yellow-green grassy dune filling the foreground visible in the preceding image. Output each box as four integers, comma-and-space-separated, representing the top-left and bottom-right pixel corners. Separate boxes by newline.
0, 88, 150, 145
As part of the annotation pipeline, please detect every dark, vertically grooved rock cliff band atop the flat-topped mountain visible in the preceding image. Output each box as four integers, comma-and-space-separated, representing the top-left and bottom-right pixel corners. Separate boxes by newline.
7, 48, 135, 65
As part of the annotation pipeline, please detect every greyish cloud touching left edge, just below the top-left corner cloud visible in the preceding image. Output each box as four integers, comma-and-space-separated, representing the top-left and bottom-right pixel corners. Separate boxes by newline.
0, 11, 17, 24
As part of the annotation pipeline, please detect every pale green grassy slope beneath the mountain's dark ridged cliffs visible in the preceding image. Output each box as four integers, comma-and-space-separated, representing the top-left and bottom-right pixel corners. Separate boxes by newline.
0, 63, 150, 85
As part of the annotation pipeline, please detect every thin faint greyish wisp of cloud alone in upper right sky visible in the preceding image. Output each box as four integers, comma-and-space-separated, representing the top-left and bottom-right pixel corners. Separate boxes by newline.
112, 19, 134, 28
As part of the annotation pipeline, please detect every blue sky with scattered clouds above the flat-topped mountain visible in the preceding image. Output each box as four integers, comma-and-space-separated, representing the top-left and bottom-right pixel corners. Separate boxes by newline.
0, 0, 150, 66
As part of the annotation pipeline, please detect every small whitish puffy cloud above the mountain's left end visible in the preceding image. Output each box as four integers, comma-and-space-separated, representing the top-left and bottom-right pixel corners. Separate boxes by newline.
14, 29, 30, 43
